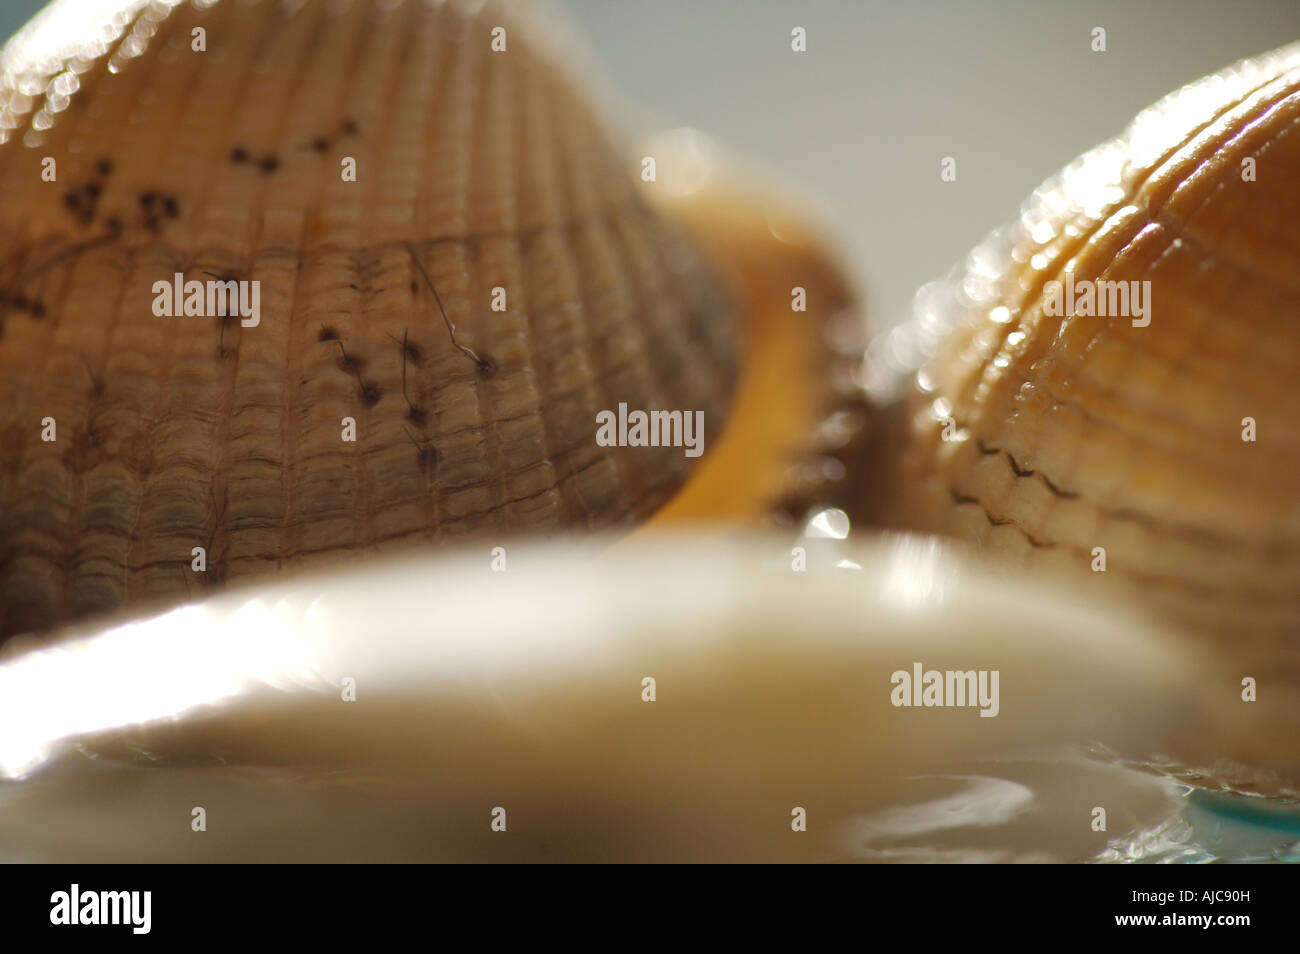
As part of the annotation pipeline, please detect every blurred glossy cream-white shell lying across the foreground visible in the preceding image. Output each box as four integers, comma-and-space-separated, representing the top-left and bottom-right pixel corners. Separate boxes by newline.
0, 533, 1274, 863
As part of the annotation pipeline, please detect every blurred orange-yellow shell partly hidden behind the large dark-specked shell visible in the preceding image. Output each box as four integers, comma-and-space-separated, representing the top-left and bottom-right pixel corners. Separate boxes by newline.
632, 155, 874, 530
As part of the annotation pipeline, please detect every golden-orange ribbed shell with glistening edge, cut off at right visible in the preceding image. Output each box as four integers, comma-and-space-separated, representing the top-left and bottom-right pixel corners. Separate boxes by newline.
875, 47, 1300, 662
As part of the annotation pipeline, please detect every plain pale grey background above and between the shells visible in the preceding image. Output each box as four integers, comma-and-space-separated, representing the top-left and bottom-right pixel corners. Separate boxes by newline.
0, 0, 1300, 324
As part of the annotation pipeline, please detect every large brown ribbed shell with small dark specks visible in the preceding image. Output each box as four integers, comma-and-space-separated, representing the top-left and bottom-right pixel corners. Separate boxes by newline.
0, 0, 737, 636
